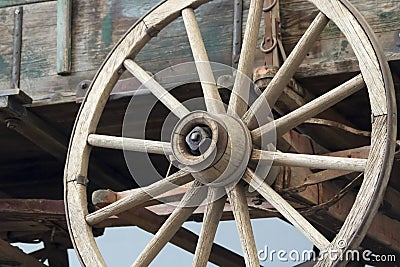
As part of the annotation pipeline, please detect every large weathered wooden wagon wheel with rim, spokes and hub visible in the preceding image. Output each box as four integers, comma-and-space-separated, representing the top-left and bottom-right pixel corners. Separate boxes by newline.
65, 0, 396, 266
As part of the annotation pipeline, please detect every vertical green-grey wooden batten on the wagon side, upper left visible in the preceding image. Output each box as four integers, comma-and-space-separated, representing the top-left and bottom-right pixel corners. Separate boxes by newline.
57, 0, 72, 75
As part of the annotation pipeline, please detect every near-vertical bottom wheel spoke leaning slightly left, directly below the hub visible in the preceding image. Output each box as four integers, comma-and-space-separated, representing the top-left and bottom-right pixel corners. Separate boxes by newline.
193, 187, 226, 267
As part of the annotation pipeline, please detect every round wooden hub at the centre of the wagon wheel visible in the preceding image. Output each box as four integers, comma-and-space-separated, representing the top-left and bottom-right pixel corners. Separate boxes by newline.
171, 111, 252, 187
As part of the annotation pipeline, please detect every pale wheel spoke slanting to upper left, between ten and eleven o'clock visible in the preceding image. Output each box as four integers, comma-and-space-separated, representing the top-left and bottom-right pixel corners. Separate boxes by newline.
124, 59, 189, 118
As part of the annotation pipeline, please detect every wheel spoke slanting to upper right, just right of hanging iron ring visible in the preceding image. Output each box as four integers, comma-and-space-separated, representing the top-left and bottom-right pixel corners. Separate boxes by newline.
243, 13, 329, 129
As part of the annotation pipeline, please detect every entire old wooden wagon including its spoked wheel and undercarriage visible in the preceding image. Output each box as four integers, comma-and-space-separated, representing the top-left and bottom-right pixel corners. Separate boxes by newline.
0, 0, 400, 266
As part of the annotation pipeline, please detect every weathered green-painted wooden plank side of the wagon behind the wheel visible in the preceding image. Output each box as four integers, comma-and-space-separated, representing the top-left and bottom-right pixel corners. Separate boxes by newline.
0, 0, 400, 104
